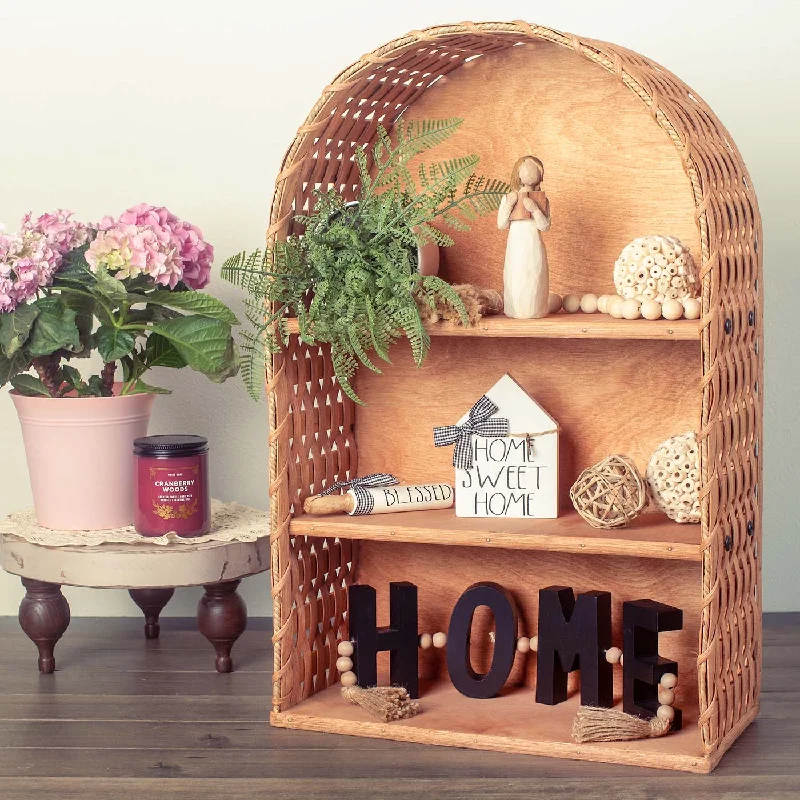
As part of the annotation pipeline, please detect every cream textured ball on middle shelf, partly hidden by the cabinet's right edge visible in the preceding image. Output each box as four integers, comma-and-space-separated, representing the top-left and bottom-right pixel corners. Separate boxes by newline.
647, 433, 700, 522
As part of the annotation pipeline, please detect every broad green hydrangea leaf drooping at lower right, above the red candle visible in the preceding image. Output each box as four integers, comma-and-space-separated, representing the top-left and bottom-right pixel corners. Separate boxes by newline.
153, 317, 239, 383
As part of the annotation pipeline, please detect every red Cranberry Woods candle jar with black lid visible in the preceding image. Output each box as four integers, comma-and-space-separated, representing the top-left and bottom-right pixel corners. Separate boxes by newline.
133, 435, 211, 537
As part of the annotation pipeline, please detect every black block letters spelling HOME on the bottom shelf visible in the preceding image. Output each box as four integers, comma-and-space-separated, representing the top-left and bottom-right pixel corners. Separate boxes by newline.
348, 582, 683, 730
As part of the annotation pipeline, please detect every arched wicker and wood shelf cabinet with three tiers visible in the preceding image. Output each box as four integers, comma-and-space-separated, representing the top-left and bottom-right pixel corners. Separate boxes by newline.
267, 22, 763, 772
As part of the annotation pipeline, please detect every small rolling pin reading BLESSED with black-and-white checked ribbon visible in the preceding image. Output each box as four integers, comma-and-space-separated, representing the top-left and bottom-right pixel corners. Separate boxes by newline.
303, 483, 455, 515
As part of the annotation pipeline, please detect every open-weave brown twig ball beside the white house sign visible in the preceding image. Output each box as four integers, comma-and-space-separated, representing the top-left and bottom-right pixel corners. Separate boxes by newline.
569, 455, 647, 528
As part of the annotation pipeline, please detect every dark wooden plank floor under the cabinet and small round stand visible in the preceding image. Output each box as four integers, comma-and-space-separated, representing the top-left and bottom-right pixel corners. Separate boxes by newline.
0, 614, 800, 800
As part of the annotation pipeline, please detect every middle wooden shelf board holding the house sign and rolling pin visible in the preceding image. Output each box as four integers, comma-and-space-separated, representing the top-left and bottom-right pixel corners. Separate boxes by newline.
290, 509, 700, 561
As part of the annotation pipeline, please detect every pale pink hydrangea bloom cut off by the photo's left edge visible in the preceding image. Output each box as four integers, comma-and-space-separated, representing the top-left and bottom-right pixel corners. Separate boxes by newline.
0, 226, 62, 313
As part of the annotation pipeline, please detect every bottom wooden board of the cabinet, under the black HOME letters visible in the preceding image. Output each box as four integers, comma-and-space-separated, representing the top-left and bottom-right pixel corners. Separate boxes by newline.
270, 680, 715, 773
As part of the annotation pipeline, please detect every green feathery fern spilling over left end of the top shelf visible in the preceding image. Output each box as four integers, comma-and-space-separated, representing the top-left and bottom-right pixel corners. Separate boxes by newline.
222, 119, 509, 403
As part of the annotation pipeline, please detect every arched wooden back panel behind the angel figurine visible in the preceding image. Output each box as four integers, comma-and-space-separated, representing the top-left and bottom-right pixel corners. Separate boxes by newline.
404, 42, 700, 294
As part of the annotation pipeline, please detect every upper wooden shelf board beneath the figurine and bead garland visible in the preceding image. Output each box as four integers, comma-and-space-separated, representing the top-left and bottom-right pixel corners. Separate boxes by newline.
287, 312, 700, 341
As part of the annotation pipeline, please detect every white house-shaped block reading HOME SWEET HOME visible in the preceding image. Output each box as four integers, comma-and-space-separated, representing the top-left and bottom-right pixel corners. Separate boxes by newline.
455, 375, 558, 519
